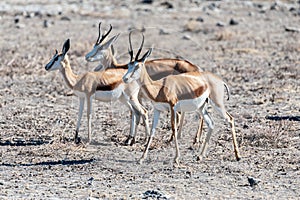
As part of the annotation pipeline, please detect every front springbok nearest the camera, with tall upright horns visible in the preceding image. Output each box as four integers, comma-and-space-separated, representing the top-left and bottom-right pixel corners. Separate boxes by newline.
123, 35, 240, 165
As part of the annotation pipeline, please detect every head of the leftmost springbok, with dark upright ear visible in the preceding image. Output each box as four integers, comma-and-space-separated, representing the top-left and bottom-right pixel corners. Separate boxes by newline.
45, 39, 70, 71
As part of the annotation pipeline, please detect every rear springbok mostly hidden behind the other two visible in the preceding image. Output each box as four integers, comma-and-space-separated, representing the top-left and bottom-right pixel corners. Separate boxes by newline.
85, 22, 203, 145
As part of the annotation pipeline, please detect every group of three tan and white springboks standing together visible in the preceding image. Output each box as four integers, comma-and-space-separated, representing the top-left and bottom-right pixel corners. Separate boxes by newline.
45, 23, 240, 165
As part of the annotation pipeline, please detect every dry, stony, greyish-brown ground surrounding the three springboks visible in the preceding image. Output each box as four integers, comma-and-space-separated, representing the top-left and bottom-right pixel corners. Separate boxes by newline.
0, 0, 300, 199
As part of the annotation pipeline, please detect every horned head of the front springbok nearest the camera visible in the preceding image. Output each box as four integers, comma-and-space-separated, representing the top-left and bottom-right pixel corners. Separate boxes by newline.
123, 32, 152, 83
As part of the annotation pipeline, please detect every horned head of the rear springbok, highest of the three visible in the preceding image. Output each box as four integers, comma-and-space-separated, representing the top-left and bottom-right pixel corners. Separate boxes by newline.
85, 22, 120, 68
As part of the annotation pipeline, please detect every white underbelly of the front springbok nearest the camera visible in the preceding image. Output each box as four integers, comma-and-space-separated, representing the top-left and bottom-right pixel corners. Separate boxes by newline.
174, 90, 209, 112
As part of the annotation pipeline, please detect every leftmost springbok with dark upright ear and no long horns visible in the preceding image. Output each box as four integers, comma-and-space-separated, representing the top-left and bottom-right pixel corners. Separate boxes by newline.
45, 39, 149, 144
